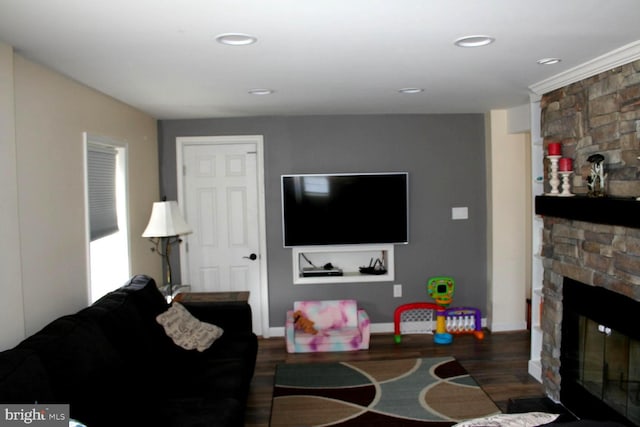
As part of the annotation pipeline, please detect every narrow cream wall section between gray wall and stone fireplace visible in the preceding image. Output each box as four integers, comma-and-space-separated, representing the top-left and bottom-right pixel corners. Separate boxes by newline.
486, 110, 529, 332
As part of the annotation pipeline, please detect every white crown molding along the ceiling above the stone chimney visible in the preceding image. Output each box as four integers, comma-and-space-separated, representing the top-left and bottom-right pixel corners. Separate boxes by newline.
529, 40, 640, 96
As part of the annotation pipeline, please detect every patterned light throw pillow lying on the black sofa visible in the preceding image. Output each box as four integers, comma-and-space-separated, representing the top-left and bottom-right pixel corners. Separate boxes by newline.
156, 302, 224, 351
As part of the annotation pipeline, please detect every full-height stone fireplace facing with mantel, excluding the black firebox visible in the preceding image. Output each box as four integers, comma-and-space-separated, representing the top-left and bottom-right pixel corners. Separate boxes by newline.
532, 55, 640, 422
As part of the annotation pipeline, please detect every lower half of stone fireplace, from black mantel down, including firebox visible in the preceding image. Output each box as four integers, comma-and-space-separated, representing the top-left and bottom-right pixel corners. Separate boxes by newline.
536, 200, 640, 424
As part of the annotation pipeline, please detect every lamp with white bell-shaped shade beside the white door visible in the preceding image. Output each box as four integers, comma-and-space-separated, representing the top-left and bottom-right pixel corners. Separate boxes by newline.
142, 201, 192, 300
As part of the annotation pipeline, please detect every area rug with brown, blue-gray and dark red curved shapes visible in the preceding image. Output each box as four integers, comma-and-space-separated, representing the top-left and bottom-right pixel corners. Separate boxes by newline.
270, 357, 500, 427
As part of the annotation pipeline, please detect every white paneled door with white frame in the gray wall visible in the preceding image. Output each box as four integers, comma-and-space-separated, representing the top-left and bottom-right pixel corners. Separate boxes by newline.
177, 136, 268, 336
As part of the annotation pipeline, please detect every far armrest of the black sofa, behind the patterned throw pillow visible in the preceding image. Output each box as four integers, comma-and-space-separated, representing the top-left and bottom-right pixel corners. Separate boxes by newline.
180, 301, 253, 336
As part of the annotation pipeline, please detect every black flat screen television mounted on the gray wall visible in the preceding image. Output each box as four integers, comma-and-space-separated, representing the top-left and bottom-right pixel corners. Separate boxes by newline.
281, 172, 409, 247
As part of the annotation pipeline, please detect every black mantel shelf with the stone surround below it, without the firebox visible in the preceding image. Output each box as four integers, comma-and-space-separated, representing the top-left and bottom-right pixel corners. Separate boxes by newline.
536, 196, 640, 424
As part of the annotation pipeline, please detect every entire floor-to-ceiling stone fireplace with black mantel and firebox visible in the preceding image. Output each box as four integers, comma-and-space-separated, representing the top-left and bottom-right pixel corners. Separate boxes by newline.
536, 61, 640, 425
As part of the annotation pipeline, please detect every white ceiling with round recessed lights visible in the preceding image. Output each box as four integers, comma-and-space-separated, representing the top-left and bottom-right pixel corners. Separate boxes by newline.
0, 0, 640, 119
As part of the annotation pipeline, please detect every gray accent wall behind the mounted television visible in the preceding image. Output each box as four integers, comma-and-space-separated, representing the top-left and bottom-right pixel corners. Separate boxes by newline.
158, 114, 487, 327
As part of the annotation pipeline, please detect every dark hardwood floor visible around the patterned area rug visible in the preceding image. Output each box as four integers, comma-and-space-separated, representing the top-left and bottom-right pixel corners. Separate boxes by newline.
245, 331, 544, 427
